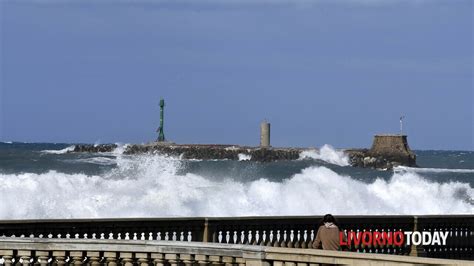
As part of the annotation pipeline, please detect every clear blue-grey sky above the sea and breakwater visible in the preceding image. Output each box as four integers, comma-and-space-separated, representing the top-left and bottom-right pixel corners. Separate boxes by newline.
0, 0, 474, 150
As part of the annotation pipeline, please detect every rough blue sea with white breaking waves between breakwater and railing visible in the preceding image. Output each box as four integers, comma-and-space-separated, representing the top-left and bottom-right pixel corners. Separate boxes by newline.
0, 142, 474, 219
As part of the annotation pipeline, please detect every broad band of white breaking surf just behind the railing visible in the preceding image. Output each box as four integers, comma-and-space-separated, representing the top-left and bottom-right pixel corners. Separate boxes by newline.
0, 156, 474, 219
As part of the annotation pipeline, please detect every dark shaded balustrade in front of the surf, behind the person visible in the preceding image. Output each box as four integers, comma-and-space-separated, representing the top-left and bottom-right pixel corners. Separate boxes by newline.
0, 215, 474, 260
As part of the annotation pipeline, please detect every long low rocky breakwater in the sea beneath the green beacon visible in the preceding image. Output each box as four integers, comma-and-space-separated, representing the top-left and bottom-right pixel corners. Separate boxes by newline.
72, 136, 416, 169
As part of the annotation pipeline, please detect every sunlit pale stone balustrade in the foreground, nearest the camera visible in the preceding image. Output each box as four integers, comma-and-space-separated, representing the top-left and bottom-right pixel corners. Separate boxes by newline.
0, 237, 470, 266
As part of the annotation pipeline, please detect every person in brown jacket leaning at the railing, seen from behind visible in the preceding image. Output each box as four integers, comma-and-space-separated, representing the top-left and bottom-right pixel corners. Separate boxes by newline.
313, 214, 347, 250
